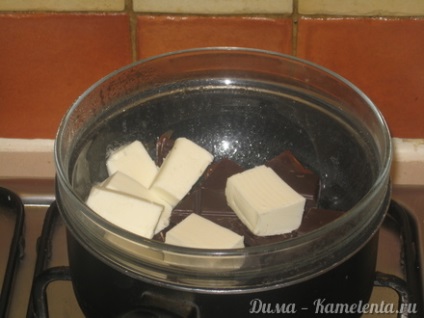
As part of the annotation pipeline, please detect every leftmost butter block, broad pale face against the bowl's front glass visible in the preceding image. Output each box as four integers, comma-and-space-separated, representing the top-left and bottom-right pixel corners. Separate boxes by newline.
86, 186, 163, 238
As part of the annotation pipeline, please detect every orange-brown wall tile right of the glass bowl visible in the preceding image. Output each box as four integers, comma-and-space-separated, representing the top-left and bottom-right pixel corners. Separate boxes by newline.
297, 18, 424, 138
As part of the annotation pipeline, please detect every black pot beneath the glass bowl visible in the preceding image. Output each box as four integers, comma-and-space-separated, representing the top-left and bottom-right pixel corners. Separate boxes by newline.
68, 227, 378, 318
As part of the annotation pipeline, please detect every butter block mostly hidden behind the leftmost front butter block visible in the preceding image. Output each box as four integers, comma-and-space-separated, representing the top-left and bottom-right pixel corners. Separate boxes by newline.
102, 171, 172, 234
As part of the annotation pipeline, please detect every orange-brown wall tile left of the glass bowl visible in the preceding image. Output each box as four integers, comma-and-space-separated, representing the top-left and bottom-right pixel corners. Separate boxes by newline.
0, 14, 131, 138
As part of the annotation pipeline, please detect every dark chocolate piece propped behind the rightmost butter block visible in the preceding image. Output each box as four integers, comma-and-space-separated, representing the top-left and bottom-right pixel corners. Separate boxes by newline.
265, 150, 320, 211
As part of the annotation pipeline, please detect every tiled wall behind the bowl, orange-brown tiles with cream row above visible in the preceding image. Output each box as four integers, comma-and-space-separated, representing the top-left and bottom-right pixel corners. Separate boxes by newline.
0, 0, 424, 138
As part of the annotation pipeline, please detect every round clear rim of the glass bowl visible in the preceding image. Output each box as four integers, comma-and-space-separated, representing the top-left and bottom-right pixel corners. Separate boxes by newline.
54, 46, 393, 256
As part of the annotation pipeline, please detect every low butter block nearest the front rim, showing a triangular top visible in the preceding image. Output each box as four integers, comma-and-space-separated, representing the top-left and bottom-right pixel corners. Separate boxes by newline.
165, 213, 244, 249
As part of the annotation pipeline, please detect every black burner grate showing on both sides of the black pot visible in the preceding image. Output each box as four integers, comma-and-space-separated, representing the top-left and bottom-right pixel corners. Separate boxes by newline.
27, 201, 423, 318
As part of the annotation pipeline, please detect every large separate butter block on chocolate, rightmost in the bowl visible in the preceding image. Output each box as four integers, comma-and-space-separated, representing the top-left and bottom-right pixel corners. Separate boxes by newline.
225, 166, 305, 236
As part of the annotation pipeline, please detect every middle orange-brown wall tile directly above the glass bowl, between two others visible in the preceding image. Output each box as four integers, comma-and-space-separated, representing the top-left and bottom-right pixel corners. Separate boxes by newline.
137, 15, 292, 58
